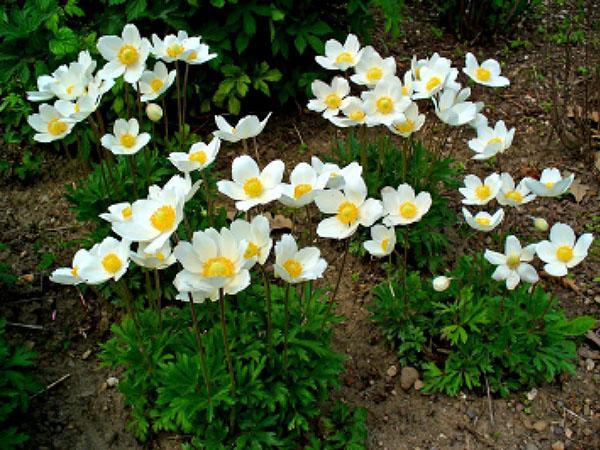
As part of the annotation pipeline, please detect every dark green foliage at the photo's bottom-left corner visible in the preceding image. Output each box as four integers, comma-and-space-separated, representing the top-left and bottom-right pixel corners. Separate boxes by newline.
0, 318, 41, 450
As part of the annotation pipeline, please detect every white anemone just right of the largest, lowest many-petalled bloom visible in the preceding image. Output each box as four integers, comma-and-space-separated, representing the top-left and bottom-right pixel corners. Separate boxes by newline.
273, 234, 327, 284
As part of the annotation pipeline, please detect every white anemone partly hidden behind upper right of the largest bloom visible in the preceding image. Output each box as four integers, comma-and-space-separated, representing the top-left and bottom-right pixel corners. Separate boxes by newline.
229, 216, 273, 269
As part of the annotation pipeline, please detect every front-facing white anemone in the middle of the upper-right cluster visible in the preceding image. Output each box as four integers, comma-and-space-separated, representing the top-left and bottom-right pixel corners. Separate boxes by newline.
361, 76, 411, 126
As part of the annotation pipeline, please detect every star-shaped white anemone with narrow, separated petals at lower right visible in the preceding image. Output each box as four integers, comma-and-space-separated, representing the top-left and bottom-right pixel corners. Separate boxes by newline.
484, 235, 540, 290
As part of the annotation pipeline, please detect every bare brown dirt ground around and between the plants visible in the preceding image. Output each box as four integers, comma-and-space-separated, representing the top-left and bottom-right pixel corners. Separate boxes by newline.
0, 1, 600, 450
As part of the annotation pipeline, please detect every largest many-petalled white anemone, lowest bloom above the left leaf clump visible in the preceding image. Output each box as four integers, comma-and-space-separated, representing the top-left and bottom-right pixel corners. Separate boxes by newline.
174, 228, 250, 298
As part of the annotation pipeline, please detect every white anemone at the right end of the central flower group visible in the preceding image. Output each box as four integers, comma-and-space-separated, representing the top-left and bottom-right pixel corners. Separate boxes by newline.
381, 183, 431, 226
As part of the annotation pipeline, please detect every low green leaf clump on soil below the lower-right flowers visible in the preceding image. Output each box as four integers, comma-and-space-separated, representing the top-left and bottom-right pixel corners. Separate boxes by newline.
371, 257, 594, 396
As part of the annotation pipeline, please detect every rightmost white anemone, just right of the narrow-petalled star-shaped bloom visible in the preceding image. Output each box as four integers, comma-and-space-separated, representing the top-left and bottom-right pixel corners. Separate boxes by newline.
536, 223, 594, 277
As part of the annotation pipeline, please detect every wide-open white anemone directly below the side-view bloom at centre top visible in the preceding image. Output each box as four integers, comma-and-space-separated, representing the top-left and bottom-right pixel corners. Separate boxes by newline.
217, 155, 284, 211
